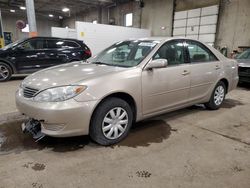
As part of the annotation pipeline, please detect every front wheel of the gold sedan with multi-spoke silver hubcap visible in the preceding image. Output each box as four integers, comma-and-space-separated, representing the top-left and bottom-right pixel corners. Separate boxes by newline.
89, 97, 133, 146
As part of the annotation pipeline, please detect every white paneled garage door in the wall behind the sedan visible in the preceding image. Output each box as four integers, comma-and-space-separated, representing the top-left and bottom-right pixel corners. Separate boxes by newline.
173, 5, 219, 45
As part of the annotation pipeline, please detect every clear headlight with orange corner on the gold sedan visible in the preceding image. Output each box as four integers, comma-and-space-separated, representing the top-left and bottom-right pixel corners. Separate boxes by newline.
34, 86, 87, 102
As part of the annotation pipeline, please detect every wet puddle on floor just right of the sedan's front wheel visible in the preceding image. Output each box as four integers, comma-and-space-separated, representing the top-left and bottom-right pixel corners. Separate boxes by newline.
117, 120, 176, 148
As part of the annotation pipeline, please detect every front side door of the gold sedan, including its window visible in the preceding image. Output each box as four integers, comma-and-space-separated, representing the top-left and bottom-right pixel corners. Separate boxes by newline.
142, 40, 190, 115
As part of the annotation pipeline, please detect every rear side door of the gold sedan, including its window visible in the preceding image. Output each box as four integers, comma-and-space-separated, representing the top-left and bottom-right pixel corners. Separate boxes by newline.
185, 40, 221, 101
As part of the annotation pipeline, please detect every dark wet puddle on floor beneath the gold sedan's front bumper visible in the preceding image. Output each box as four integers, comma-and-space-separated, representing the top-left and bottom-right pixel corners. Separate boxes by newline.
0, 121, 89, 155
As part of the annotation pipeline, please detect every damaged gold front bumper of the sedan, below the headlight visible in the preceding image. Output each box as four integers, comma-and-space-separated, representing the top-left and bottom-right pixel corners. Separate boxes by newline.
16, 92, 98, 137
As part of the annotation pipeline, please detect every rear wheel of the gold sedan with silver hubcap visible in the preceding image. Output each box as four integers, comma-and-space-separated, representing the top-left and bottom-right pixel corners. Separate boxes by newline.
205, 81, 226, 110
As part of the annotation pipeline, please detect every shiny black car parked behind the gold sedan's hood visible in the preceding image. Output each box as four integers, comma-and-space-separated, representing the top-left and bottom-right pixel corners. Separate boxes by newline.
0, 37, 91, 81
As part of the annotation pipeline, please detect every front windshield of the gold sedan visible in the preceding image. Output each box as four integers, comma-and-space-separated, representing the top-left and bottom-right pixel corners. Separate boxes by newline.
89, 40, 159, 67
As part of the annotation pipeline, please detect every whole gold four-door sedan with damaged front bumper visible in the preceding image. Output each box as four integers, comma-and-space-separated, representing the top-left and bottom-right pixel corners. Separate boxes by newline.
16, 38, 238, 145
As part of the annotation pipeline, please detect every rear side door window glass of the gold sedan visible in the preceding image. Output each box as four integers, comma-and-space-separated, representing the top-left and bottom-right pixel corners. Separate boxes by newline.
186, 41, 218, 63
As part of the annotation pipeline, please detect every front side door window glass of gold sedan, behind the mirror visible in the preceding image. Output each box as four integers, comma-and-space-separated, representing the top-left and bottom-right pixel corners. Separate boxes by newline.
153, 41, 185, 65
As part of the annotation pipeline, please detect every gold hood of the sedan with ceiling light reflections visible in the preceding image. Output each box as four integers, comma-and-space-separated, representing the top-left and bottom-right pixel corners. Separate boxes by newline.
22, 62, 126, 90
